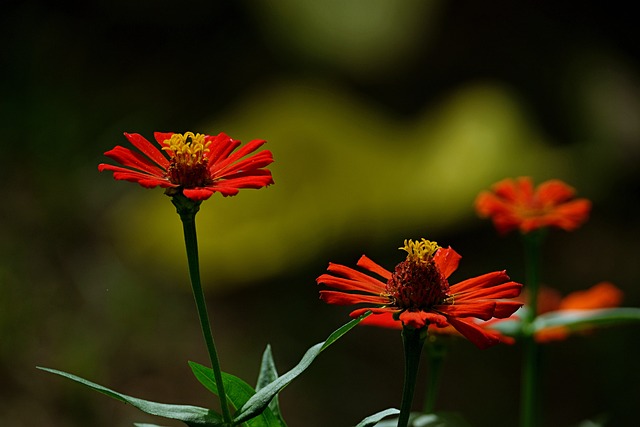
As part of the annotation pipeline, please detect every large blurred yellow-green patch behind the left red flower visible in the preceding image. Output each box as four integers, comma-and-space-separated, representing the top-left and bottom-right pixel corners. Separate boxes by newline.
111, 83, 576, 285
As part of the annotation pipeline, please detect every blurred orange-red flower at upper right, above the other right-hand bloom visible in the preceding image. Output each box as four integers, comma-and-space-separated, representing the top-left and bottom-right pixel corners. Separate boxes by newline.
475, 177, 591, 233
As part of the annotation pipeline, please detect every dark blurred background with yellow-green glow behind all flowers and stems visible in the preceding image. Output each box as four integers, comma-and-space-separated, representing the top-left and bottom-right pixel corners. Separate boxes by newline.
0, 0, 640, 427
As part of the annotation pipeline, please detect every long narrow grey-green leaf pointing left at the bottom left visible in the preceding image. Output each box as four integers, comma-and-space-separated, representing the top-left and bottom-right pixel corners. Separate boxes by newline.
38, 367, 223, 427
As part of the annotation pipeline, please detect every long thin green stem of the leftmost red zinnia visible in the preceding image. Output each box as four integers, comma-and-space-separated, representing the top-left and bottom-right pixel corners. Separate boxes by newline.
171, 194, 231, 425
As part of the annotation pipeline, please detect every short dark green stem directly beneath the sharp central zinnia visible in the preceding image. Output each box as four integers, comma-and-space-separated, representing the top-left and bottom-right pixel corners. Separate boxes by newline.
398, 326, 427, 427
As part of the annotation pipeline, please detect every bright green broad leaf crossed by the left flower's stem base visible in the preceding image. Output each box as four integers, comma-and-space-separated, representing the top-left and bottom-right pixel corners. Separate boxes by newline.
189, 362, 282, 427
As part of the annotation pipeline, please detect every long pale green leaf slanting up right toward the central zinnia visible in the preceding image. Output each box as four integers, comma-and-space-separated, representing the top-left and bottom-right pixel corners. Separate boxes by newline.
233, 311, 371, 424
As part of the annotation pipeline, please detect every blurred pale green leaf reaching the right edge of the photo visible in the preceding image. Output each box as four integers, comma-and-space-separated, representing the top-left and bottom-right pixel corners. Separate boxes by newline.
533, 307, 640, 332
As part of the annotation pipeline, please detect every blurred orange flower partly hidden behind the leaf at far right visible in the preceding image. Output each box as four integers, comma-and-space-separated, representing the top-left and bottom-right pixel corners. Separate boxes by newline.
535, 282, 622, 343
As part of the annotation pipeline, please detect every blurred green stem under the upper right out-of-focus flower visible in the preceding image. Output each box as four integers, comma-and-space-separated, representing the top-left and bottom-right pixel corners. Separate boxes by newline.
520, 229, 545, 427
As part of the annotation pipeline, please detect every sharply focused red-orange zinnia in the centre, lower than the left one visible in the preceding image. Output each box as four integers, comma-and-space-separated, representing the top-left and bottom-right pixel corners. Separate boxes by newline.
317, 239, 522, 348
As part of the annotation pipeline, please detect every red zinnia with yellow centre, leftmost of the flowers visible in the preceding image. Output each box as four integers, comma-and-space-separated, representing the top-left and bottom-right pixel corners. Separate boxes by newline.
98, 132, 273, 201
